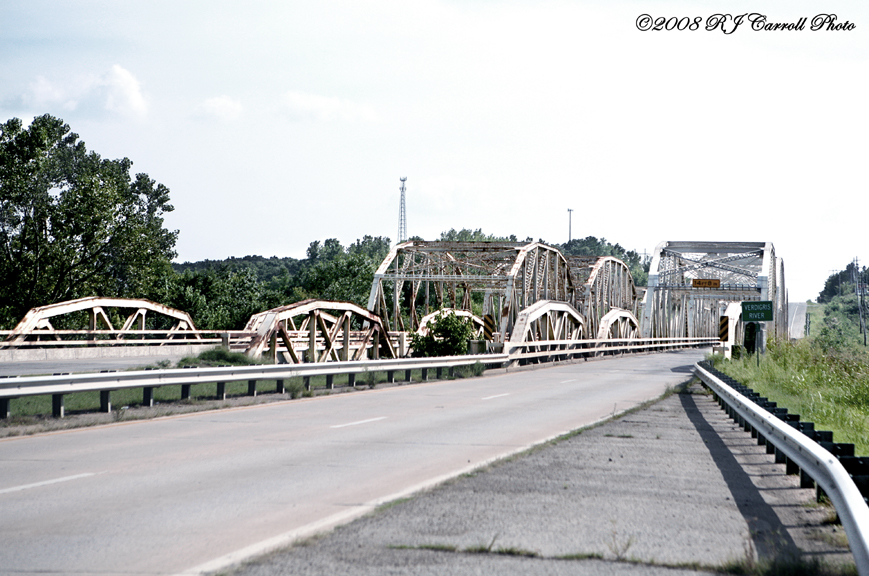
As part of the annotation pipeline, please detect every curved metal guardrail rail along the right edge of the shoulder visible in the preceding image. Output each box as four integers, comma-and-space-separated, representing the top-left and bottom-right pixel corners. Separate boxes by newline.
694, 363, 869, 576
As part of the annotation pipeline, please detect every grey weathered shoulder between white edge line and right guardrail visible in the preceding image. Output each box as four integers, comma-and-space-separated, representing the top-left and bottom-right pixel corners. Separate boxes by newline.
225, 386, 853, 576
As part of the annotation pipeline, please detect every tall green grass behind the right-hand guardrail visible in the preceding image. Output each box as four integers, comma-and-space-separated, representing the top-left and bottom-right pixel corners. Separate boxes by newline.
713, 339, 869, 454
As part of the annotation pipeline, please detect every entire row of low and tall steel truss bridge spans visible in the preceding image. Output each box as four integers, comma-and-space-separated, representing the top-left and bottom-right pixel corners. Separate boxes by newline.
0, 241, 787, 364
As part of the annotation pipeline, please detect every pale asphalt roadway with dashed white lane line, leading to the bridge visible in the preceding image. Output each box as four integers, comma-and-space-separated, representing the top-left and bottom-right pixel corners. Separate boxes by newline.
0, 351, 704, 574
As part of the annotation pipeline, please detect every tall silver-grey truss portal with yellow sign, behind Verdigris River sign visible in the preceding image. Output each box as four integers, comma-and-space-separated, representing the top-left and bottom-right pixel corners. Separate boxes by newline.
641, 242, 788, 337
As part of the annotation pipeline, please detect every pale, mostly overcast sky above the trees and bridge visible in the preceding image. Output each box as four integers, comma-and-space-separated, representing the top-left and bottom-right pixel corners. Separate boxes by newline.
0, 0, 869, 301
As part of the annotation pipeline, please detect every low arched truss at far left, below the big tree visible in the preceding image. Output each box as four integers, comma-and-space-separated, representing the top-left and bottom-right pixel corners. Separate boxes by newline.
6, 296, 201, 343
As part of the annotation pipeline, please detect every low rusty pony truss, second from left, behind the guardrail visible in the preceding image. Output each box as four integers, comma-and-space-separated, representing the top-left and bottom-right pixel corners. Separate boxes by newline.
244, 300, 398, 364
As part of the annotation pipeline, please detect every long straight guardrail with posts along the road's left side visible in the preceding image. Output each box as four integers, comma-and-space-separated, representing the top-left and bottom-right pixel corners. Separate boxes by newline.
0, 338, 715, 418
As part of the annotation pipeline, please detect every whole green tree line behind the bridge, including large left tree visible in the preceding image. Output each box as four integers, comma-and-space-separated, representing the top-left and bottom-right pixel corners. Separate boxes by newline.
0, 114, 648, 330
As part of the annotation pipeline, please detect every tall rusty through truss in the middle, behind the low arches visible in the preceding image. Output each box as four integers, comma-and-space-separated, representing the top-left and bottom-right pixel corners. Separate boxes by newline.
368, 241, 575, 339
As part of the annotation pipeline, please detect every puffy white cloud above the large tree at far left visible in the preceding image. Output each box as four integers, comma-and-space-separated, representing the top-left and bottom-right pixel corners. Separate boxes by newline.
21, 64, 148, 117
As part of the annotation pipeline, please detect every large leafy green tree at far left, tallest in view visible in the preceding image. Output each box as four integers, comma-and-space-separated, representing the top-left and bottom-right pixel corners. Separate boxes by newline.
0, 114, 178, 326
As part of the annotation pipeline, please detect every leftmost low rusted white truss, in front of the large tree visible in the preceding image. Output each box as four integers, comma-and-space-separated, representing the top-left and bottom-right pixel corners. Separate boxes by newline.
0, 296, 201, 347
